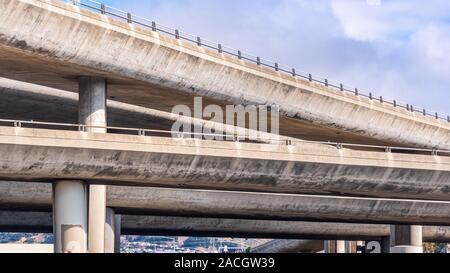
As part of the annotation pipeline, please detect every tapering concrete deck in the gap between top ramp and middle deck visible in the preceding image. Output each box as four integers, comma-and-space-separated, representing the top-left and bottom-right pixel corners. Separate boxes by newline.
0, 78, 293, 143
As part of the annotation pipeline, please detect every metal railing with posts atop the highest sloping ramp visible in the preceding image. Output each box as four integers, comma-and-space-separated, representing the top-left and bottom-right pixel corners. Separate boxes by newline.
60, 0, 450, 122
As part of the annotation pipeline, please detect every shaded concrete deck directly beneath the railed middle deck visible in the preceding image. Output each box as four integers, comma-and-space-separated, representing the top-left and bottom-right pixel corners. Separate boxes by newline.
0, 182, 450, 226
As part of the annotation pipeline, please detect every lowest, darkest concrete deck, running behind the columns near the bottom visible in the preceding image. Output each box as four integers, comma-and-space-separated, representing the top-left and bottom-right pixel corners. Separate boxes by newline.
0, 211, 450, 243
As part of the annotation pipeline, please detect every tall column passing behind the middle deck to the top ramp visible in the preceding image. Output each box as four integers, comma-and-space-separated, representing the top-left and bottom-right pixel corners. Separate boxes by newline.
78, 77, 107, 253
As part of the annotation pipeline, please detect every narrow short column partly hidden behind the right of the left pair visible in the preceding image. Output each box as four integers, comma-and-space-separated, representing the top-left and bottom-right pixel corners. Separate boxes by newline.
105, 208, 121, 253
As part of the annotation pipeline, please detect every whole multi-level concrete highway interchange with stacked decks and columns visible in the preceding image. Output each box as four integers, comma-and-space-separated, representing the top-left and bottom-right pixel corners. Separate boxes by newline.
0, 0, 450, 253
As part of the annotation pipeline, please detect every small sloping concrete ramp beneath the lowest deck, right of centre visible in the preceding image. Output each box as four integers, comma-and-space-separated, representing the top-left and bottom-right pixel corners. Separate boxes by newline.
251, 240, 323, 253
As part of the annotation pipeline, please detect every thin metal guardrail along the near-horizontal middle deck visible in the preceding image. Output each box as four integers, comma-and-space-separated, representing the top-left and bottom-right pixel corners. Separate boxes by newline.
0, 119, 450, 156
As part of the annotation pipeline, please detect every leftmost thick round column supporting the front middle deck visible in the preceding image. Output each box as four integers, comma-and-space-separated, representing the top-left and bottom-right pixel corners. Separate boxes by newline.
53, 180, 88, 253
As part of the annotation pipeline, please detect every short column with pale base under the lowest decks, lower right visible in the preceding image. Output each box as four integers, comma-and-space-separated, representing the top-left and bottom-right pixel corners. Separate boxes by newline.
391, 225, 423, 253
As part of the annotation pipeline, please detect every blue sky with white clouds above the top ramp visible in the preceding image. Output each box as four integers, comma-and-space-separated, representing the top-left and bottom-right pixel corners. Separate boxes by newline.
103, 0, 450, 115
